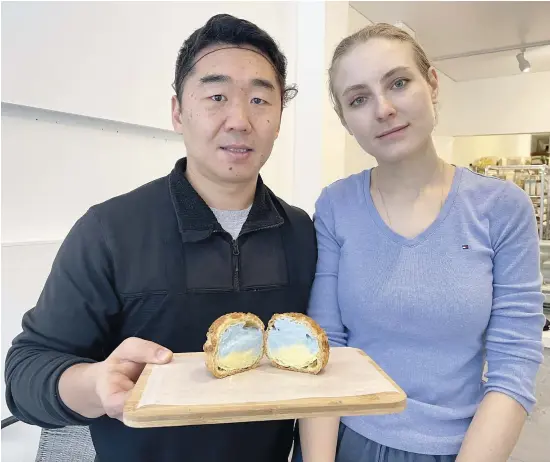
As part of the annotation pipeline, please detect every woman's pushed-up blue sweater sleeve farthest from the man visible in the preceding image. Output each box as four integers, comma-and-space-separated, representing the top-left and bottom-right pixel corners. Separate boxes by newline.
485, 182, 544, 412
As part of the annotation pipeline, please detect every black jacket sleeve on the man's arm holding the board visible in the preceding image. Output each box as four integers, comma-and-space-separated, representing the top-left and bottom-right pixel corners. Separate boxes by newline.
5, 209, 119, 428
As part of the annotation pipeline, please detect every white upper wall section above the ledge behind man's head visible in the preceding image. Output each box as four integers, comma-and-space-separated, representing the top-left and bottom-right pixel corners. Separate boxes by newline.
2, 1, 295, 129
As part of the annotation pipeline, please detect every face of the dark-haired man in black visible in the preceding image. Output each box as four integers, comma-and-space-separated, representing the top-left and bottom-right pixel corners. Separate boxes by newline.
172, 45, 282, 184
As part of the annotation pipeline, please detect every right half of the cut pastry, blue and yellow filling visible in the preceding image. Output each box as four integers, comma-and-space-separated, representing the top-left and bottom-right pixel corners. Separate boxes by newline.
265, 313, 330, 374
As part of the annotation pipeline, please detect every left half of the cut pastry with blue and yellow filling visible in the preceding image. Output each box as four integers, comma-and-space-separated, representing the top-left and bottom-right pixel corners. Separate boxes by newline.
203, 313, 265, 379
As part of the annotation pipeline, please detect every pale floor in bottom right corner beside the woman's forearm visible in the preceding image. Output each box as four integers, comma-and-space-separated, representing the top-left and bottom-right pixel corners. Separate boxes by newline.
509, 348, 550, 462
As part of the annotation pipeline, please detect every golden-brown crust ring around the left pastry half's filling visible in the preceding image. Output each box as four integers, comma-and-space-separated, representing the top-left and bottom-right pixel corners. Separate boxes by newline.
202, 313, 265, 379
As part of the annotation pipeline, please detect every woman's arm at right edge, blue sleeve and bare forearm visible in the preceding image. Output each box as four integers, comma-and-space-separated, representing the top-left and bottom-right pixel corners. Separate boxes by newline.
457, 183, 544, 462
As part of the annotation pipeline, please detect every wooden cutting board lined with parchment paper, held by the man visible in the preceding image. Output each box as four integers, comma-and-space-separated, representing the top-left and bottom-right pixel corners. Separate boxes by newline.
123, 347, 406, 428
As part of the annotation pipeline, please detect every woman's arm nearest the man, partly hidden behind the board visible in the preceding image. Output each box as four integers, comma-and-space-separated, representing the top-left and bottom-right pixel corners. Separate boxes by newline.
299, 189, 347, 462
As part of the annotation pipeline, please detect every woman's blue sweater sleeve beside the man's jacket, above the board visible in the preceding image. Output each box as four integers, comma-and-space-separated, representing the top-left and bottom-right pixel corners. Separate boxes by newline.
308, 188, 347, 346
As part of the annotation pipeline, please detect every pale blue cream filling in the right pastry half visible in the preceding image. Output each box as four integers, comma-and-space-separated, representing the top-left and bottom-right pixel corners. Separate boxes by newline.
267, 318, 319, 356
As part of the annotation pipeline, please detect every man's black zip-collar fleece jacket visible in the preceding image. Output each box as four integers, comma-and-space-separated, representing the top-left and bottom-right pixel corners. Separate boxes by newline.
5, 159, 317, 462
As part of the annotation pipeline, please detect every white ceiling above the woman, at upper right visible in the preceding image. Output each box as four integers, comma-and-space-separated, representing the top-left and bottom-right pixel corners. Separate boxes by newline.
350, 1, 550, 81
